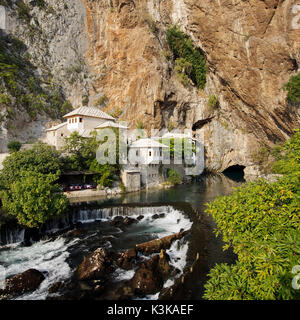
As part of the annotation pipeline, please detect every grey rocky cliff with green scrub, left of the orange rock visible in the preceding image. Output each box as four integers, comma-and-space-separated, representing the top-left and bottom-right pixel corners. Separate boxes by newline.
0, 0, 93, 152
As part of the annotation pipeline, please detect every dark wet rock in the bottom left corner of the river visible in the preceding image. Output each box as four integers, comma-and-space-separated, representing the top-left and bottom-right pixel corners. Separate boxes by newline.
0, 269, 45, 299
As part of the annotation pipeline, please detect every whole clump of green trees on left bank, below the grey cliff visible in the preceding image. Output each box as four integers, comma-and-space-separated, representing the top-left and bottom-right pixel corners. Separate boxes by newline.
0, 143, 68, 228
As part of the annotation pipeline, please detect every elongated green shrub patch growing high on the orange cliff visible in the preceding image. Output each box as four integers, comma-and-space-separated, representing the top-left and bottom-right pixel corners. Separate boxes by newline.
167, 26, 207, 89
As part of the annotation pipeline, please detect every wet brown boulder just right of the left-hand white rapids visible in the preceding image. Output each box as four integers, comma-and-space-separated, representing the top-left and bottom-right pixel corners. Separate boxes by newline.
77, 248, 114, 280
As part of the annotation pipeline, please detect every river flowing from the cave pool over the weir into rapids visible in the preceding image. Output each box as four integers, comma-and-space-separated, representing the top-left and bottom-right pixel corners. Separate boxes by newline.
0, 175, 243, 300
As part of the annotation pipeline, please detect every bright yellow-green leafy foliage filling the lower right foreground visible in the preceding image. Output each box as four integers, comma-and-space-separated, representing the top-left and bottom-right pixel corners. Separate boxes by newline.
204, 131, 300, 300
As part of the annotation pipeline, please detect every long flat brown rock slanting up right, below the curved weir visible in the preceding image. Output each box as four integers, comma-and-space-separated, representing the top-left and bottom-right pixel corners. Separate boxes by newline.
135, 231, 187, 254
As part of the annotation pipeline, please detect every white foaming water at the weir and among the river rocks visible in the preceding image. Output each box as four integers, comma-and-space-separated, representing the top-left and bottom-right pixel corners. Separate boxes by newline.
0, 206, 192, 300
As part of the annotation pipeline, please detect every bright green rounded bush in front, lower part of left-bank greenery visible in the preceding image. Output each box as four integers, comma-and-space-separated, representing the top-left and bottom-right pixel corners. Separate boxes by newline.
0, 171, 69, 228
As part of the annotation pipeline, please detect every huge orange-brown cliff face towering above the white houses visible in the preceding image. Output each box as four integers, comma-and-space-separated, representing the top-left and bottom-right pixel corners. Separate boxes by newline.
0, 0, 300, 172
